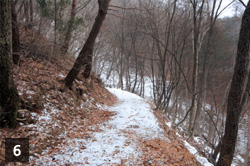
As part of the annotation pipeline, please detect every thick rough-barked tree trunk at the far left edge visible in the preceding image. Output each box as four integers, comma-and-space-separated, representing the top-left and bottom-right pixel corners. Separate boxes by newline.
0, 0, 19, 128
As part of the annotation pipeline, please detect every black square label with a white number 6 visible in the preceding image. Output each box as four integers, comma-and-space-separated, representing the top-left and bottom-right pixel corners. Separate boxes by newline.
5, 138, 29, 162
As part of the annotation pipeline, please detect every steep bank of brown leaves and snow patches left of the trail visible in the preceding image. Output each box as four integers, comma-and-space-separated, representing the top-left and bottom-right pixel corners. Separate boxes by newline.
0, 53, 116, 165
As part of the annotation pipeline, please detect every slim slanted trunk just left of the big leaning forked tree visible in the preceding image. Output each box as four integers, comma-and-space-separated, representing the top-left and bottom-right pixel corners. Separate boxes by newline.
61, 0, 76, 52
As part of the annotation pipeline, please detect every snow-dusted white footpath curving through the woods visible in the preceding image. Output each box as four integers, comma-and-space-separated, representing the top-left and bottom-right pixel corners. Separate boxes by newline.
47, 89, 164, 165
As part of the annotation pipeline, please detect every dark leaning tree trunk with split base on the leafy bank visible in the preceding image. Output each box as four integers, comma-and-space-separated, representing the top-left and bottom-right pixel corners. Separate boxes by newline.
65, 0, 110, 87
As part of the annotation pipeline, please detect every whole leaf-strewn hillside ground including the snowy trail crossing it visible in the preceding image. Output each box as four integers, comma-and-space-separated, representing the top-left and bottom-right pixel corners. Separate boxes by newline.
0, 26, 211, 165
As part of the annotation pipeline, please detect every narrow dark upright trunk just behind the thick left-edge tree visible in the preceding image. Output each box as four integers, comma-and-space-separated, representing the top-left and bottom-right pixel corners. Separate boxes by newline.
11, 0, 20, 64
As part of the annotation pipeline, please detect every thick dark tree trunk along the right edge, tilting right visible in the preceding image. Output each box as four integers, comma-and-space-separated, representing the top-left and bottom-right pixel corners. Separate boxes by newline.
216, 1, 250, 166
